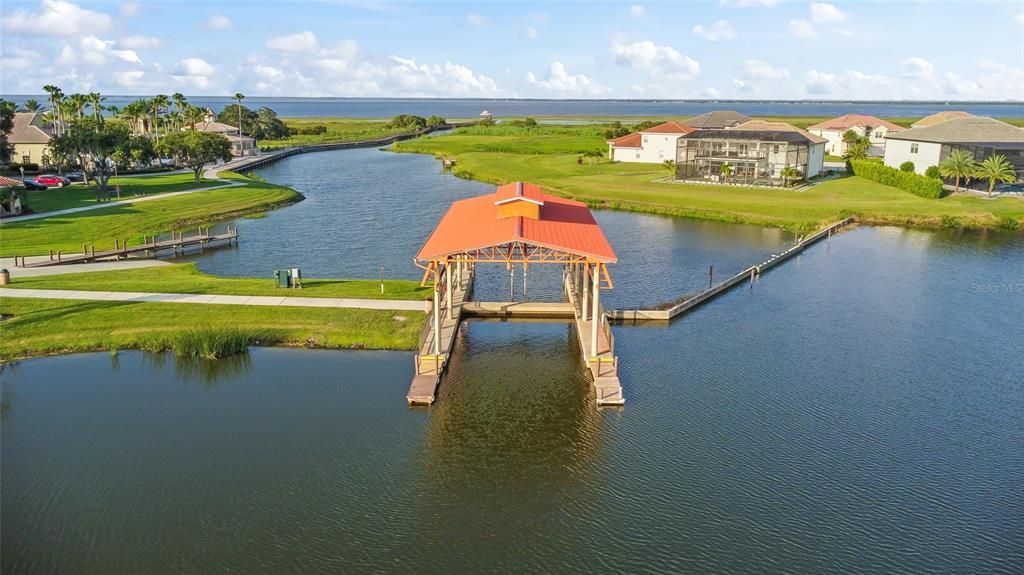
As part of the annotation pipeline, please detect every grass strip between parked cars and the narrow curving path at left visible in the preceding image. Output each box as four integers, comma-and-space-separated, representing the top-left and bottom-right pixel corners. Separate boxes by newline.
28, 173, 222, 214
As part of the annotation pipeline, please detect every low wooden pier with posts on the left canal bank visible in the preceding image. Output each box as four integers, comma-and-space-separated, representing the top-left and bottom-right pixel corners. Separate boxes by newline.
14, 226, 239, 268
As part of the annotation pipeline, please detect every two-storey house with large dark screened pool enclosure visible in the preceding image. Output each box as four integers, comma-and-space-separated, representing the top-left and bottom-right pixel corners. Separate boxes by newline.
676, 120, 827, 186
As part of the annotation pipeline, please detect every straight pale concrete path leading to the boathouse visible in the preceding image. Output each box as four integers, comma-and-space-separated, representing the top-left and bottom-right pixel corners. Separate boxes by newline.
0, 288, 427, 312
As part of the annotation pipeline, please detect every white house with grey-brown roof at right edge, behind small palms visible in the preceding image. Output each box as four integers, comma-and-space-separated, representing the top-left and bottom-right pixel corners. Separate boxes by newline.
885, 115, 1024, 178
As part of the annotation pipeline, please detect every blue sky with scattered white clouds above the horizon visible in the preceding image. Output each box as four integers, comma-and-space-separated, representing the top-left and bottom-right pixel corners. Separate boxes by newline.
0, 0, 1024, 100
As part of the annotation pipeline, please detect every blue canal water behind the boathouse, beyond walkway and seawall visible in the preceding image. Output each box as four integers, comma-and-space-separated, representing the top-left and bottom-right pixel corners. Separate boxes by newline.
187, 148, 793, 307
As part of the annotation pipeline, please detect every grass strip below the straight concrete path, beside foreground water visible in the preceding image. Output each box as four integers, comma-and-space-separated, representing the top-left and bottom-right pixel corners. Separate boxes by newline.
0, 298, 426, 361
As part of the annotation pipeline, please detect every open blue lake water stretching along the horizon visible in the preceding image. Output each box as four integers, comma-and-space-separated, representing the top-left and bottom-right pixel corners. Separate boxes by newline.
4, 95, 1024, 118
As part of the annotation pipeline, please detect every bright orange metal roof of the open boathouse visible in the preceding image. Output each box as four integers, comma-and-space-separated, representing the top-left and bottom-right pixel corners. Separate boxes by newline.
416, 182, 618, 263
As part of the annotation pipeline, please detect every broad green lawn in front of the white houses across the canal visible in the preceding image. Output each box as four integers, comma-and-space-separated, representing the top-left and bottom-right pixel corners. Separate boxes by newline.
394, 126, 1024, 232
